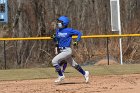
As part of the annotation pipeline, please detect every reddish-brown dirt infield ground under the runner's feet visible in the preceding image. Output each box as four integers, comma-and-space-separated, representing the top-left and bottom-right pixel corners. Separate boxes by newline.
0, 74, 140, 93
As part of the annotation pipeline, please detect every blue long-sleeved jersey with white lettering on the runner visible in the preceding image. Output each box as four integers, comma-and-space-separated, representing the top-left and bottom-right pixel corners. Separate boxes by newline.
56, 28, 82, 47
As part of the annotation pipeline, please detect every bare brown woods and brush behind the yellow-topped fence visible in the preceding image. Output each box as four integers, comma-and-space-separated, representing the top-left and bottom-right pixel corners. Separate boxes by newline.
0, 0, 140, 68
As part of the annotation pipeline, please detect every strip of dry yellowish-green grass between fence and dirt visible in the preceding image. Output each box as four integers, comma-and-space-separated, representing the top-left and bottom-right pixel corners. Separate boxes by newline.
0, 64, 140, 80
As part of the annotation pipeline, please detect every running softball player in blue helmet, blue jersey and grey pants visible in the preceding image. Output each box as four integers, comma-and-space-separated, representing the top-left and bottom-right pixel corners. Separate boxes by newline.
52, 16, 89, 83
